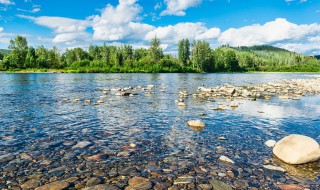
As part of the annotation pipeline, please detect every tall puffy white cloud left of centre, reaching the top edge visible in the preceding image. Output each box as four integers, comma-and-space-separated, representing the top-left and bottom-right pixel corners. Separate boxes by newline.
89, 0, 154, 41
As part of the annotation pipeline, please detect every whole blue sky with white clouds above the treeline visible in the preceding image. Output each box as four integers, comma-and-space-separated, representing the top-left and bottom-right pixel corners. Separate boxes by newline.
0, 0, 320, 55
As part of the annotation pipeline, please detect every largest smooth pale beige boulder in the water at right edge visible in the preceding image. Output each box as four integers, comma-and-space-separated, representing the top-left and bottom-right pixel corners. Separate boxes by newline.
273, 135, 320, 164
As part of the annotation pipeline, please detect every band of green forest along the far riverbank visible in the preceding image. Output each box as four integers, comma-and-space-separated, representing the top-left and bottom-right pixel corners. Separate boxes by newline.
0, 36, 320, 73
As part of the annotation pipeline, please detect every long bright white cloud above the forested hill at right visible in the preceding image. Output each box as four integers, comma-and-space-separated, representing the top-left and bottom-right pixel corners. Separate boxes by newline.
219, 18, 320, 46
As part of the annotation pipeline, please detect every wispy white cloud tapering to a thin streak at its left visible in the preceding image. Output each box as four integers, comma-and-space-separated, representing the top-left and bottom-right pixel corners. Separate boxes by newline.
17, 15, 90, 43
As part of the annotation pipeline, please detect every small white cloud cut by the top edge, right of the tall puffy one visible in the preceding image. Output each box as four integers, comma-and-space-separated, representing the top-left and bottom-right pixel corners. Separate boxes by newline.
160, 0, 202, 16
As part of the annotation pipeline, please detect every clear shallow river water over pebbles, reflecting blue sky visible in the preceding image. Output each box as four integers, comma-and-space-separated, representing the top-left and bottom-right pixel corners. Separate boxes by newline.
0, 73, 320, 189
